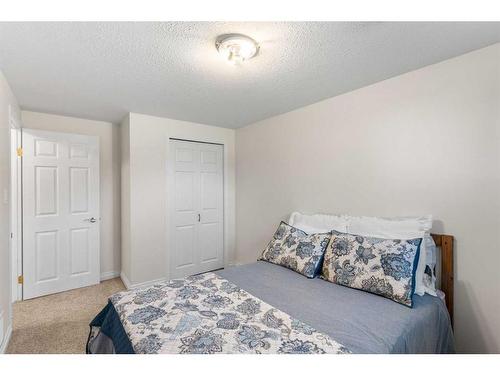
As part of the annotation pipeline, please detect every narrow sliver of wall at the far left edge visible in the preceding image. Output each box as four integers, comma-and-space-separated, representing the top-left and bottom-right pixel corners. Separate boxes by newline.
0, 71, 20, 353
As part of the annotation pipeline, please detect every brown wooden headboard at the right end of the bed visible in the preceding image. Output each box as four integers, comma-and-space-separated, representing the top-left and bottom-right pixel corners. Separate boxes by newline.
431, 234, 454, 325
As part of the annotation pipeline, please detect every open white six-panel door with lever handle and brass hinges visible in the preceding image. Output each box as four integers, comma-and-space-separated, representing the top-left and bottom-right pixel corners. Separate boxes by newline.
22, 129, 100, 299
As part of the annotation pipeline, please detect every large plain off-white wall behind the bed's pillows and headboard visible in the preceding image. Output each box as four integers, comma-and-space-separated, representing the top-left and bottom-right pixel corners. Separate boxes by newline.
236, 44, 500, 353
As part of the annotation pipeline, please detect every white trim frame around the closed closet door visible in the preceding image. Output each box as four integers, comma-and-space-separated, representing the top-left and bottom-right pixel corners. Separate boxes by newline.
165, 137, 225, 280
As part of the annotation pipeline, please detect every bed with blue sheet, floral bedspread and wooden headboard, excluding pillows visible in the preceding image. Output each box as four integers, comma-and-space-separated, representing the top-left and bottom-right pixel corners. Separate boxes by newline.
87, 235, 455, 354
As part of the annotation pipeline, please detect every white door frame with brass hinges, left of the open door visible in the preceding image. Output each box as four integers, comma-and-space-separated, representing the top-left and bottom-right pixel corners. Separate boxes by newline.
9, 113, 23, 302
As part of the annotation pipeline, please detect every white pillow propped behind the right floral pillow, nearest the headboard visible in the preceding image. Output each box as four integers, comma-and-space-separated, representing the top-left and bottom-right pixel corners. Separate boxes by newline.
347, 215, 436, 296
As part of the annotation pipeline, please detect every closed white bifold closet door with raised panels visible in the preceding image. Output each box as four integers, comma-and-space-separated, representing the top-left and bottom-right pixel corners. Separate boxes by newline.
167, 140, 224, 278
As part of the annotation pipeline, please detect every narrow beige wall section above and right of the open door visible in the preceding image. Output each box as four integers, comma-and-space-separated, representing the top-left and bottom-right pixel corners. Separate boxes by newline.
22, 111, 121, 278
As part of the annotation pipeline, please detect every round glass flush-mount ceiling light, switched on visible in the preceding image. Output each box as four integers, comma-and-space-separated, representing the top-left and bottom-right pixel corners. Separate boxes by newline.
215, 34, 259, 65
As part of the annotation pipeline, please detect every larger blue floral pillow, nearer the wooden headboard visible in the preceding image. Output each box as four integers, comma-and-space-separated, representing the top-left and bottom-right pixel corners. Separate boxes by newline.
321, 231, 422, 307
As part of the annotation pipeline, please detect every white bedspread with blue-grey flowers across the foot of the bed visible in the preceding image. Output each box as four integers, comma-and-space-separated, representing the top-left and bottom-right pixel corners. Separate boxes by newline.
111, 273, 349, 354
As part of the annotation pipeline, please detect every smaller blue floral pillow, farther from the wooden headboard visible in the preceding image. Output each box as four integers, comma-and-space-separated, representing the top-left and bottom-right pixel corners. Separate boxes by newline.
261, 221, 331, 278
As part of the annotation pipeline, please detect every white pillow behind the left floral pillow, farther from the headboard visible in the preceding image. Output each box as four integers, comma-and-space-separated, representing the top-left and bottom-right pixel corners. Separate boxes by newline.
288, 212, 348, 234
